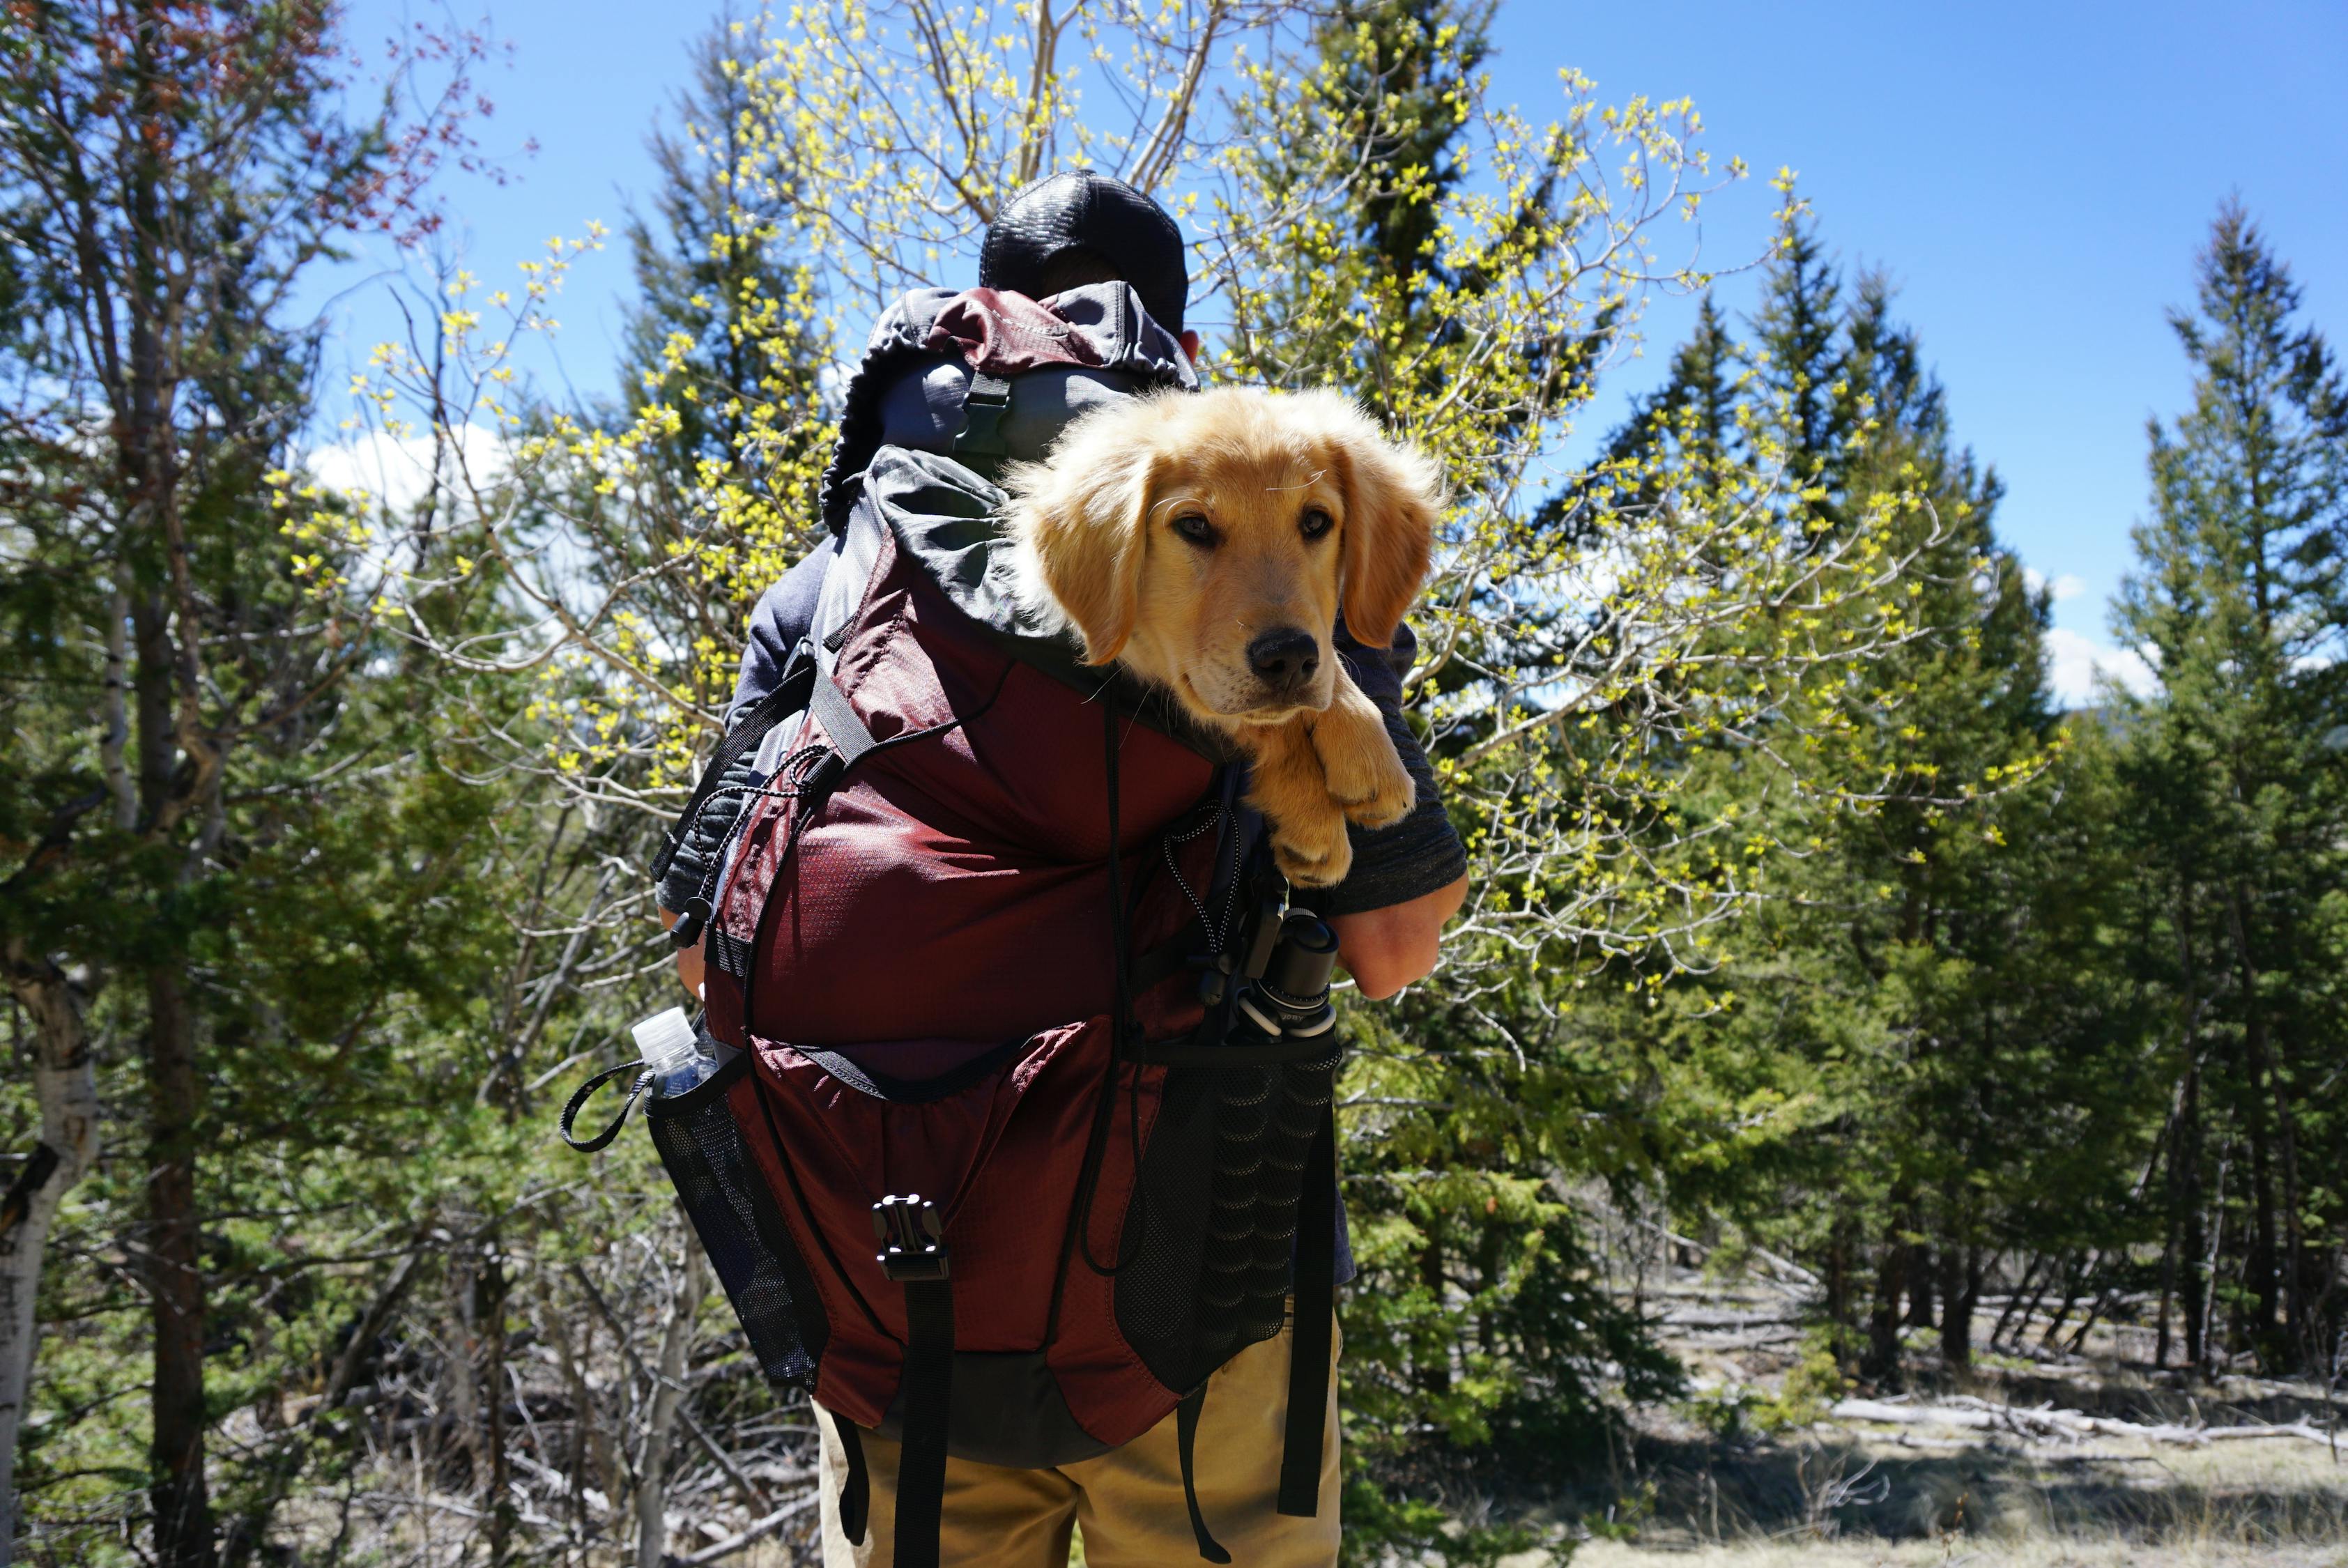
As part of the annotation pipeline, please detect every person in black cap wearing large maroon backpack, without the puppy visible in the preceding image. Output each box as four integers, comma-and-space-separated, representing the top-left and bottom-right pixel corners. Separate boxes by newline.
634, 171, 1468, 1568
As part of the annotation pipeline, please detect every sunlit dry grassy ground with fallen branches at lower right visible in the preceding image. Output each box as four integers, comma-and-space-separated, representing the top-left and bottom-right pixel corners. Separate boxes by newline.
1494, 1268, 2348, 1568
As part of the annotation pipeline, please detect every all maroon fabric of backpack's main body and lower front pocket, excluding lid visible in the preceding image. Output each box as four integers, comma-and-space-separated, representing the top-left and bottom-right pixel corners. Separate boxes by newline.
707, 523, 1214, 1443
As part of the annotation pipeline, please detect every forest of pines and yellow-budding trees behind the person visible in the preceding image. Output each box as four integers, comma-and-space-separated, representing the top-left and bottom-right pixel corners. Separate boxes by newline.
0, 0, 2348, 1568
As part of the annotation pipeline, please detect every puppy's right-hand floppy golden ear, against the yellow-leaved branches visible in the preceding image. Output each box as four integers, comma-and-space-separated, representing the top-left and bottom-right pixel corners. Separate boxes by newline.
1329, 399, 1444, 648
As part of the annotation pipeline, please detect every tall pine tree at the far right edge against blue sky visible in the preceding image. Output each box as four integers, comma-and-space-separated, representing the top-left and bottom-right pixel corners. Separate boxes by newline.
2115, 202, 2348, 1369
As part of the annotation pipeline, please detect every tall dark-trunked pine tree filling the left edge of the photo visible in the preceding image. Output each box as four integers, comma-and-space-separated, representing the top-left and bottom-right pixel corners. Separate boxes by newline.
0, 0, 516, 1568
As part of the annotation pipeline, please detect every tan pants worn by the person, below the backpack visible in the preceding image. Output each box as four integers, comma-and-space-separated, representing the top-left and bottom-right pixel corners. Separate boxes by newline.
817, 1328, 1341, 1568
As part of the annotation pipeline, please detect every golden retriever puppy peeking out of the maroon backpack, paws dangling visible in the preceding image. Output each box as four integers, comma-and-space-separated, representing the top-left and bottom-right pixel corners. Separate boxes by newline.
1010, 387, 1442, 887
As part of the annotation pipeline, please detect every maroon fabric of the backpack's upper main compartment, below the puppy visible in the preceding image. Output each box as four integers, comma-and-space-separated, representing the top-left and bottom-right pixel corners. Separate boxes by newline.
721, 523, 1214, 1045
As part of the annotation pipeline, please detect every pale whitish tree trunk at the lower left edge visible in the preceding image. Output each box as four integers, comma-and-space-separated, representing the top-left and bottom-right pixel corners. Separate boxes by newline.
0, 939, 98, 1568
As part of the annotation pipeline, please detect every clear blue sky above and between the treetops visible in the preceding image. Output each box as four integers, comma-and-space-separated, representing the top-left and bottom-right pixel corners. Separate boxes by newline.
316, 0, 2348, 697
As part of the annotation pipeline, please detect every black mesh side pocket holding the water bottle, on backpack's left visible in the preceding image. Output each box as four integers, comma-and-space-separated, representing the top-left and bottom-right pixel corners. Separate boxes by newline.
643, 1054, 831, 1390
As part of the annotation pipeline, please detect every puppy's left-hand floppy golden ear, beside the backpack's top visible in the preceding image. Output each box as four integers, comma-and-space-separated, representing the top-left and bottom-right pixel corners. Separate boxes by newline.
1010, 403, 1158, 664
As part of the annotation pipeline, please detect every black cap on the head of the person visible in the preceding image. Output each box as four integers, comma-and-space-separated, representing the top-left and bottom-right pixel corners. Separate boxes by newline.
979, 169, 1190, 333
